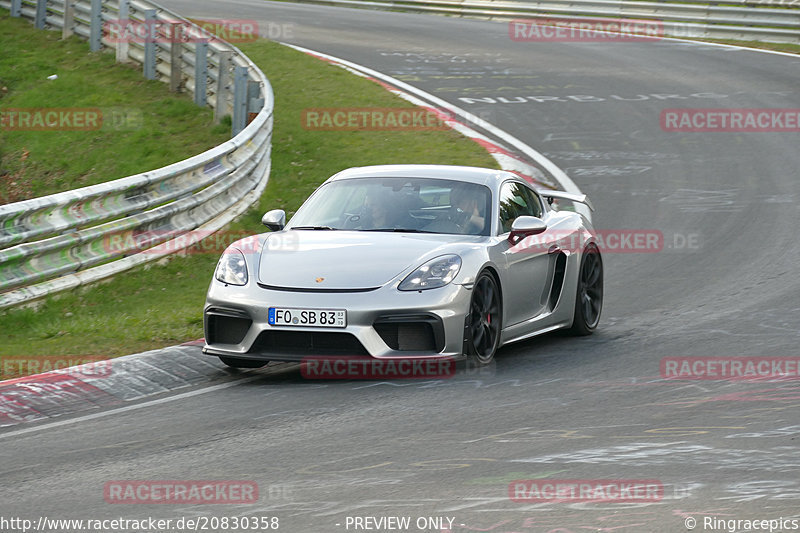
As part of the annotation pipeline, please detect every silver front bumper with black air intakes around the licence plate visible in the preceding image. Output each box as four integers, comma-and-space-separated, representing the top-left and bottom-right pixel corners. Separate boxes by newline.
203, 279, 471, 361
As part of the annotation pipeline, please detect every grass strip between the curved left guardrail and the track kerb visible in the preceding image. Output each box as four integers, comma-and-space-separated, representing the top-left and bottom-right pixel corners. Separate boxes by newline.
0, 40, 497, 366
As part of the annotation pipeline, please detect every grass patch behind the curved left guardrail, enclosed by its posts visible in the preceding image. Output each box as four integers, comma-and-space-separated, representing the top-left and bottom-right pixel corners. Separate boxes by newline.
0, 9, 230, 204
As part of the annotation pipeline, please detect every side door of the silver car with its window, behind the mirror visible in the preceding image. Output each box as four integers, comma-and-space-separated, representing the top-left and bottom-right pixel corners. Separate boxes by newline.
497, 181, 557, 327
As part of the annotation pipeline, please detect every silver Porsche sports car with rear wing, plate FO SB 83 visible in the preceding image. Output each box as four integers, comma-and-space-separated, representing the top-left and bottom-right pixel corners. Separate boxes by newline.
203, 165, 603, 368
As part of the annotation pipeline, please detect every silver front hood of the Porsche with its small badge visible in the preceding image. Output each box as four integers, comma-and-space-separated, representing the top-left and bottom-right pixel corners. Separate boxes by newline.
258, 230, 464, 290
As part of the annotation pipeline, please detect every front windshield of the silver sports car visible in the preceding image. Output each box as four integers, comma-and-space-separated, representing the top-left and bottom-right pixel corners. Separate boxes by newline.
288, 178, 492, 235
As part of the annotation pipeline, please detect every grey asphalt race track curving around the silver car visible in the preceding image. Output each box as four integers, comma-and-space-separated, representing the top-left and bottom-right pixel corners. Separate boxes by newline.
0, 0, 800, 533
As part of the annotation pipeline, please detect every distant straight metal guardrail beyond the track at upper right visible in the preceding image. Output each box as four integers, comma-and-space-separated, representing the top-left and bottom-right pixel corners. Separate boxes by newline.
294, 0, 800, 43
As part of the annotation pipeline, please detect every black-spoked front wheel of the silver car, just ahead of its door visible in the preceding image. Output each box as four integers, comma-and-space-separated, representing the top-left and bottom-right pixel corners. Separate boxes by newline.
464, 270, 503, 366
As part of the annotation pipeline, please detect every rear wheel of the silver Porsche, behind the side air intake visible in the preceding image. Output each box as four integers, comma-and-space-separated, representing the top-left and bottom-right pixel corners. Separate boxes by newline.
569, 244, 603, 336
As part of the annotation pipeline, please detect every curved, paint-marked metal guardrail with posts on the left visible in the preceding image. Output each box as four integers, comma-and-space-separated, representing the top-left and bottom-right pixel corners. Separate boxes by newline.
0, 0, 274, 308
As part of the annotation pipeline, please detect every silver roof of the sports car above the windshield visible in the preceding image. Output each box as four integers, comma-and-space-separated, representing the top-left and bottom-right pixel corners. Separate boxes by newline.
328, 165, 519, 184
